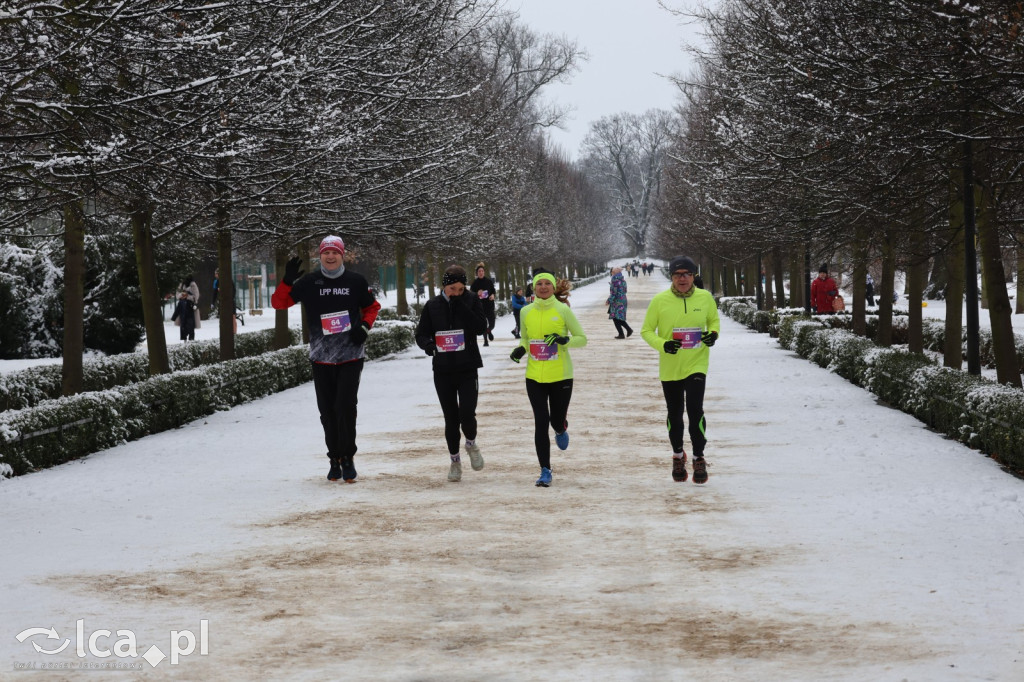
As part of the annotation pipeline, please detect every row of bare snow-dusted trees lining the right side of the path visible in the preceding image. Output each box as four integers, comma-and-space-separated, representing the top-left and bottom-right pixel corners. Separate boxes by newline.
659, 0, 1024, 386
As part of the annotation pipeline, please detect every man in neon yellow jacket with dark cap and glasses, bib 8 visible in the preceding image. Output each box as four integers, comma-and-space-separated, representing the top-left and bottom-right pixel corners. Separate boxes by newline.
640, 256, 721, 483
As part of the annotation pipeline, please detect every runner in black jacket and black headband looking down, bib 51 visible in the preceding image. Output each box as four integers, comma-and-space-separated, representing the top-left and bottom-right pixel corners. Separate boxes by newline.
416, 265, 487, 482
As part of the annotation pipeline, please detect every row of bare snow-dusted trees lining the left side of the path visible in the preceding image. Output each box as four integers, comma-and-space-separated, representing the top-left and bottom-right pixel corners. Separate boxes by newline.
0, 0, 613, 387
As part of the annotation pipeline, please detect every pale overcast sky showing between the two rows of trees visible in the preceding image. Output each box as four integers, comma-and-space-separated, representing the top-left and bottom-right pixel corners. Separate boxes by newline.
507, 0, 700, 159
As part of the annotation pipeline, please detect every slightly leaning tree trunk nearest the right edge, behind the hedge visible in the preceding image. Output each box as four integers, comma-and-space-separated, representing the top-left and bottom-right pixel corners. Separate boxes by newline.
978, 186, 1022, 388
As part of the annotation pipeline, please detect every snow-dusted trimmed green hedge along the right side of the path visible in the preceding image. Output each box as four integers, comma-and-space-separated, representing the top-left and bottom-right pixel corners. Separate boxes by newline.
721, 299, 1024, 471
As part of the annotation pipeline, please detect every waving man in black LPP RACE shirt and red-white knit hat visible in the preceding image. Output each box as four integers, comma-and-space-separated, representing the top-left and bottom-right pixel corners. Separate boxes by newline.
270, 237, 381, 483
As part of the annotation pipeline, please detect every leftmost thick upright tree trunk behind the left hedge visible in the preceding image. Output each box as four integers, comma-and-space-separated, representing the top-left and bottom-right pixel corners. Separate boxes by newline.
60, 199, 85, 395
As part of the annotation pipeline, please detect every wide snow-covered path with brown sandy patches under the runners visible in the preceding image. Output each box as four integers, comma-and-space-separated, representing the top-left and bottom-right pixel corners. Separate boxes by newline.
0, 274, 1024, 681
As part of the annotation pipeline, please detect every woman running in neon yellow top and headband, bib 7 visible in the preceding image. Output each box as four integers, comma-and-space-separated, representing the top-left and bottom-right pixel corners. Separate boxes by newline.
510, 270, 587, 487
